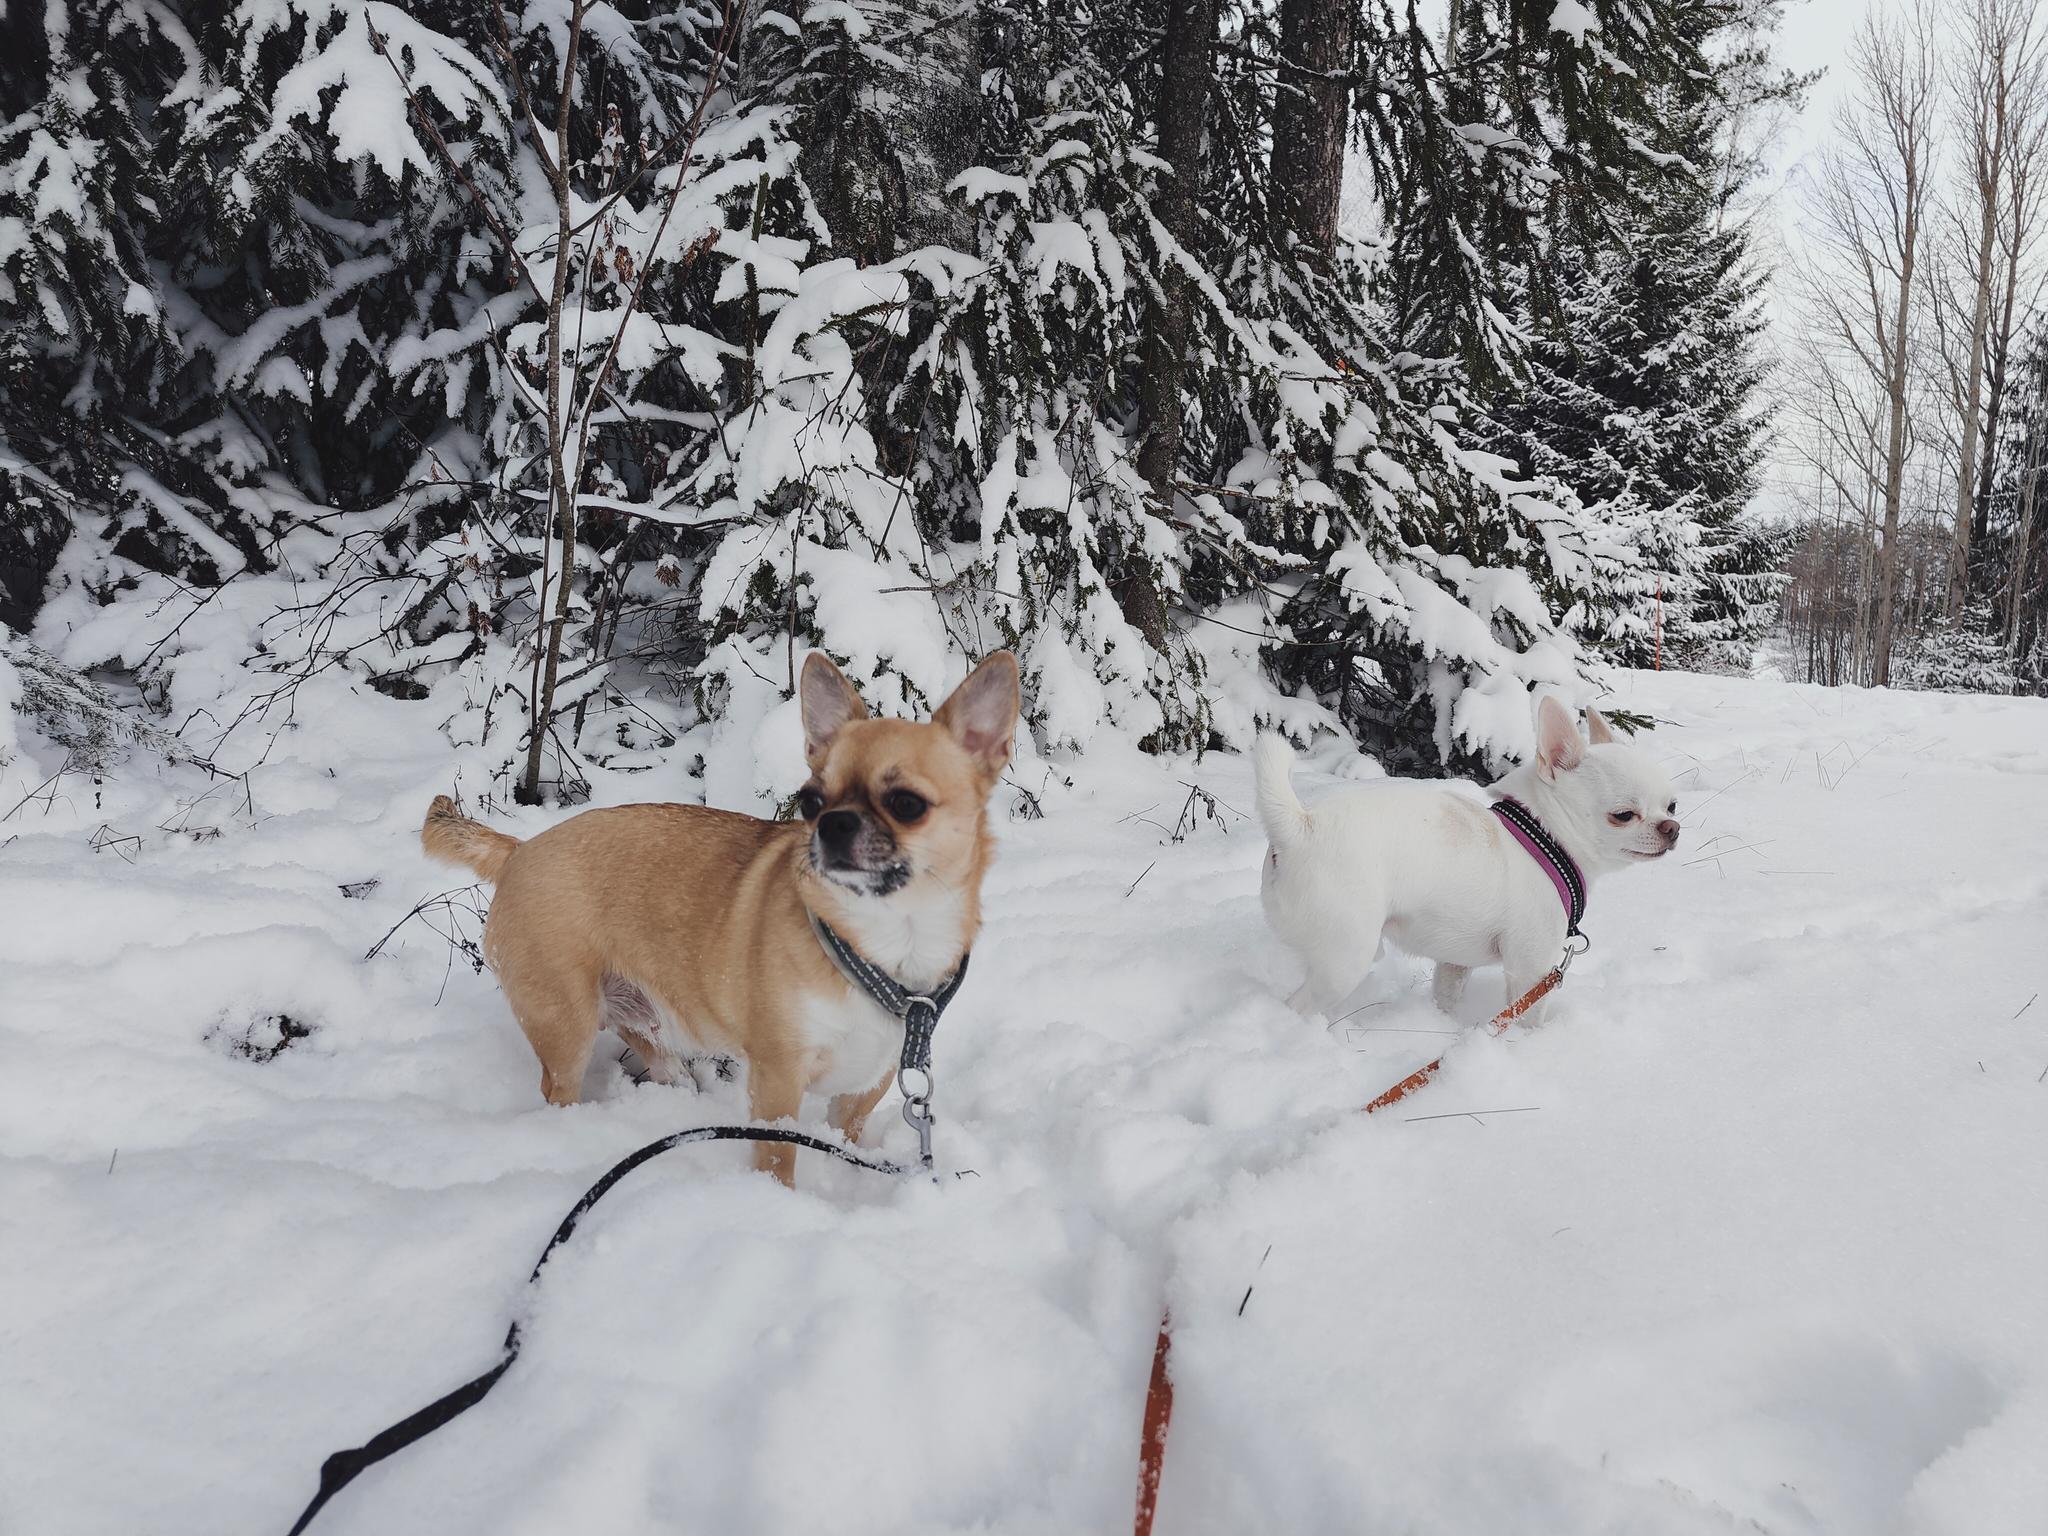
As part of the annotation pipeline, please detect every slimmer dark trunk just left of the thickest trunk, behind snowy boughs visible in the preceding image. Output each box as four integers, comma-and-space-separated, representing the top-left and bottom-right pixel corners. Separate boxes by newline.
1116, 0, 1217, 651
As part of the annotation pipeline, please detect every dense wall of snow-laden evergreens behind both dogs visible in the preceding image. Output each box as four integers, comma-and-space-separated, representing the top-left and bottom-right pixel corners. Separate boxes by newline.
0, 0, 1867, 801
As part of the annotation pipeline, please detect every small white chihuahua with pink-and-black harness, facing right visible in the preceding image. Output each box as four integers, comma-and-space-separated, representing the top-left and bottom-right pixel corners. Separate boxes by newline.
1251, 696, 1679, 1022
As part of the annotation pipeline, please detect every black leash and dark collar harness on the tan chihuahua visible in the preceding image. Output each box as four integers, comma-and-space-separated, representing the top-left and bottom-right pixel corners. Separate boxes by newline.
289, 915, 967, 1536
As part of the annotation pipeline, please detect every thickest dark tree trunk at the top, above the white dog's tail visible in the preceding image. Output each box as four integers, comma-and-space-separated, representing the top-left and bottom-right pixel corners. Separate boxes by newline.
1272, 0, 1352, 256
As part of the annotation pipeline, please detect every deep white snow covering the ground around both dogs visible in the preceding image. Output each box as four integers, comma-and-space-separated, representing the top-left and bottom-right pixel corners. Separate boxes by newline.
0, 674, 2048, 1536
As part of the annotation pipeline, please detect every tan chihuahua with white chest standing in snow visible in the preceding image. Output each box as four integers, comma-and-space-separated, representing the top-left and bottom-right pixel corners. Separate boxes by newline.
420, 651, 1018, 1184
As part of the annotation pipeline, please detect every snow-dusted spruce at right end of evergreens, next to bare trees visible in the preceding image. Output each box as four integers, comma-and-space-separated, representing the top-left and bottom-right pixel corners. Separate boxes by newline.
1489, 4, 1798, 668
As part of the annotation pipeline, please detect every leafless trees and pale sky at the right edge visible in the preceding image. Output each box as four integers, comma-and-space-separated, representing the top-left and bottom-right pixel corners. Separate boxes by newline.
1778, 0, 2048, 692
